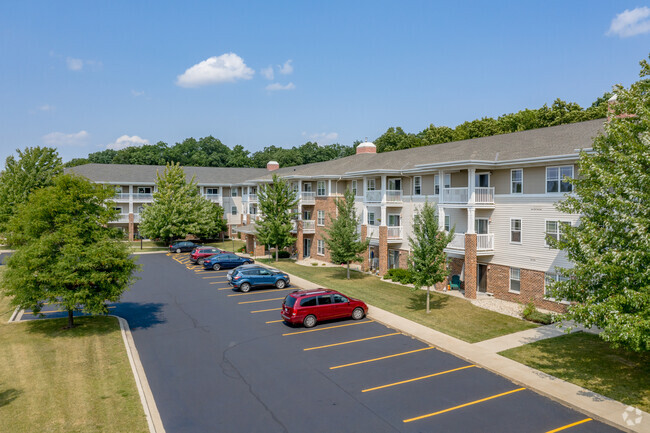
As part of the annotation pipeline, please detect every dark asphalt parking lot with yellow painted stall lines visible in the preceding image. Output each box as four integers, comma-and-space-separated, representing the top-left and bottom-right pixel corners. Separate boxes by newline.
13, 254, 617, 433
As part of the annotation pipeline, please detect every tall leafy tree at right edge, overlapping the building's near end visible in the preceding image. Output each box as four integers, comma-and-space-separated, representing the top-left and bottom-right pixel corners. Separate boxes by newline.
550, 55, 650, 351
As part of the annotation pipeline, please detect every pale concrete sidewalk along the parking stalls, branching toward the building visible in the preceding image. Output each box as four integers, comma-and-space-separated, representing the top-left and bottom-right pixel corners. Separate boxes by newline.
280, 266, 650, 433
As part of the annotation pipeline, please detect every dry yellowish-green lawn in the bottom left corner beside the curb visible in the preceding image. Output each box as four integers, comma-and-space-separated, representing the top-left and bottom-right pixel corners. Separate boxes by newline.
0, 267, 149, 433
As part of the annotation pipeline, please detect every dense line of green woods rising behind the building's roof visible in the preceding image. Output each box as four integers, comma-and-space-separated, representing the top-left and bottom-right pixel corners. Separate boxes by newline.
65, 93, 611, 168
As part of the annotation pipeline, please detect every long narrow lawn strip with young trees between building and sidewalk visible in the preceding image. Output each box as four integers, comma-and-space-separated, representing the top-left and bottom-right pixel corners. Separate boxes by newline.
260, 260, 537, 343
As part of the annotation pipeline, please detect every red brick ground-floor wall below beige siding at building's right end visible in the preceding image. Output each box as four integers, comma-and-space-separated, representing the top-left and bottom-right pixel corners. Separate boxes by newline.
487, 264, 566, 313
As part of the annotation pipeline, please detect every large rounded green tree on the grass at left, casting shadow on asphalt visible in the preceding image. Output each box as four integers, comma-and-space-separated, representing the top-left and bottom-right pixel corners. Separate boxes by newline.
2, 175, 137, 328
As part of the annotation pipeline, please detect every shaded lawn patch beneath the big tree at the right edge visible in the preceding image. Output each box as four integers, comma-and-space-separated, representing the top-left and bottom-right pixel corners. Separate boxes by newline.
500, 332, 650, 412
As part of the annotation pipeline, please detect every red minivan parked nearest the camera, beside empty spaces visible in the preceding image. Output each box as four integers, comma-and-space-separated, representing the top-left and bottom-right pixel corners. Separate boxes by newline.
281, 289, 368, 328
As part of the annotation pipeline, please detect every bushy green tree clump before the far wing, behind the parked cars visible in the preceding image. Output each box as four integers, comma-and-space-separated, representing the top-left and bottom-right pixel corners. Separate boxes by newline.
139, 164, 223, 241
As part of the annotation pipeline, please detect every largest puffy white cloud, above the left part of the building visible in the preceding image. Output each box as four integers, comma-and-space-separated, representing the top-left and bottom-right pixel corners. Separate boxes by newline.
176, 53, 255, 87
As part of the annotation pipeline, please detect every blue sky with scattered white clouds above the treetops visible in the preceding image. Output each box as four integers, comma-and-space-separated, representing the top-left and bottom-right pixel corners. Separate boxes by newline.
0, 0, 650, 161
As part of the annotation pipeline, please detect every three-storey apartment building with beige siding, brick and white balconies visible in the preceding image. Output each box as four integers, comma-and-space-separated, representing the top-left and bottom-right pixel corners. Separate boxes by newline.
71, 120, 604, 311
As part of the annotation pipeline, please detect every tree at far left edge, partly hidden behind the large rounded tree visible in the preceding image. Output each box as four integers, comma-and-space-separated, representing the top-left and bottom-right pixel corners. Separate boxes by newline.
0, 147, 63, 232
